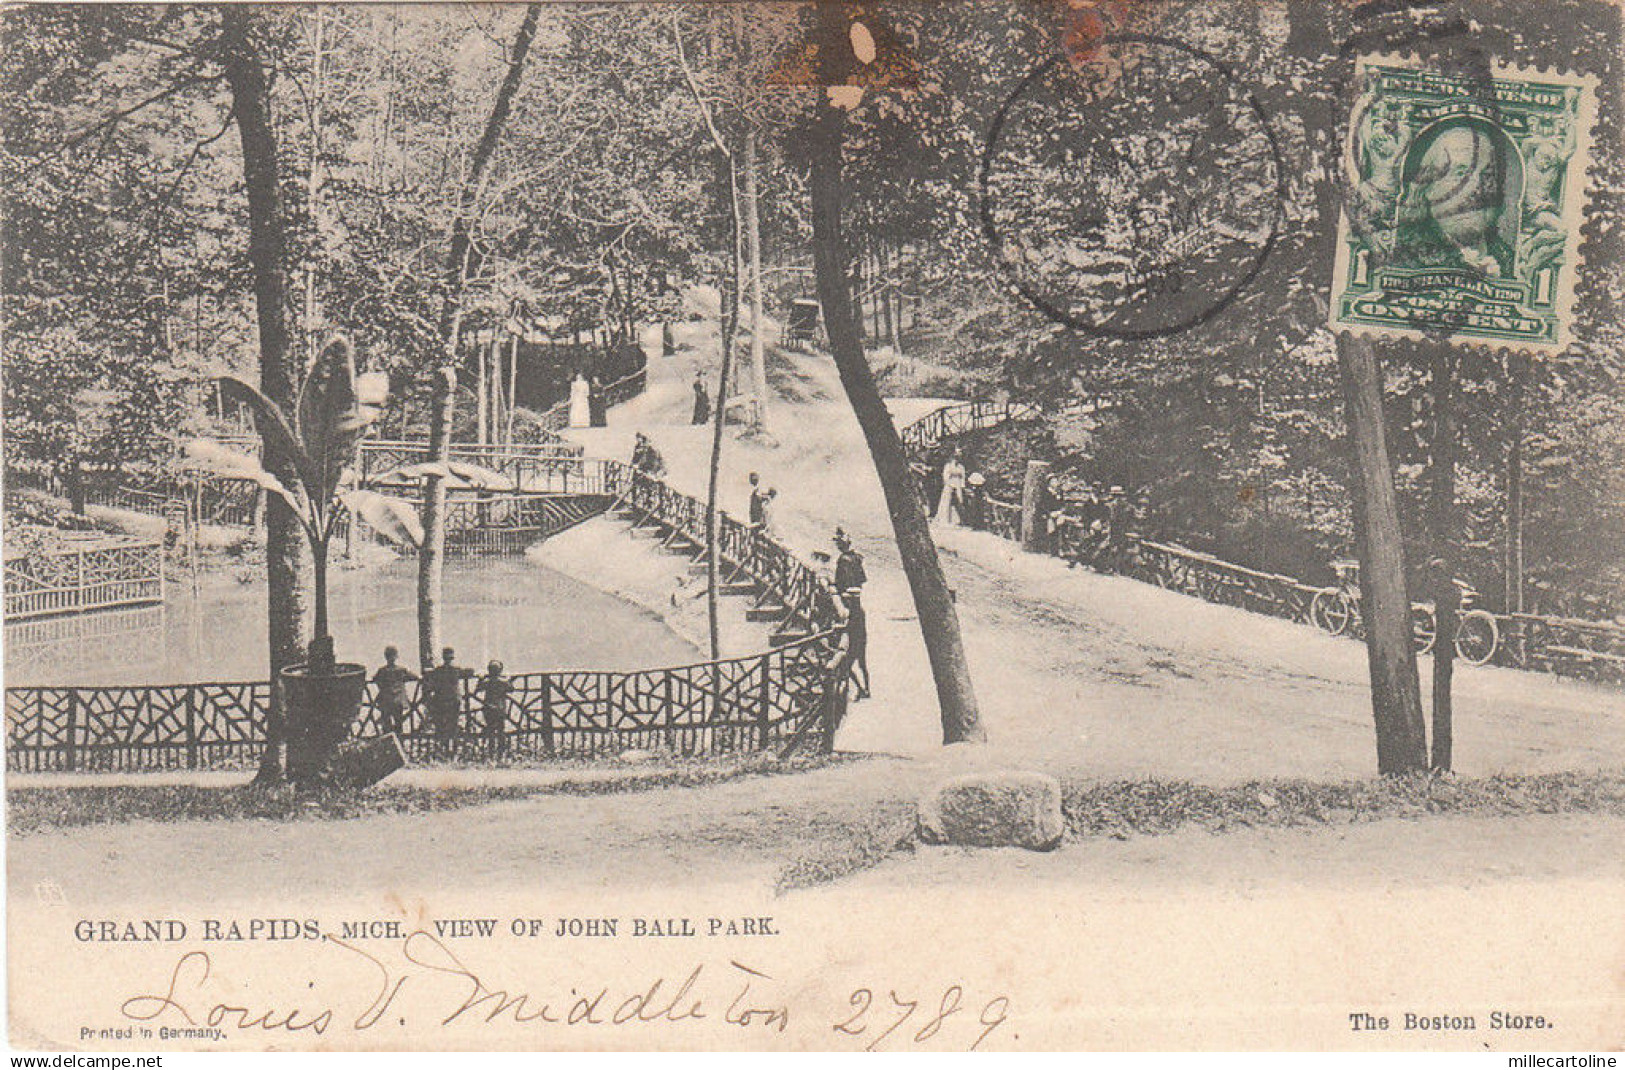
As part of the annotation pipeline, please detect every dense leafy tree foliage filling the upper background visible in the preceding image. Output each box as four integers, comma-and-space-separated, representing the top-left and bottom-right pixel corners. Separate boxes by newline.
0, 0, 1625, 615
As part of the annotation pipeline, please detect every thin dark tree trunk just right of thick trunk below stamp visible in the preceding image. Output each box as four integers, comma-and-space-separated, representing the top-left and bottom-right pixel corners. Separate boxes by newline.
1428, 341, 1461, 772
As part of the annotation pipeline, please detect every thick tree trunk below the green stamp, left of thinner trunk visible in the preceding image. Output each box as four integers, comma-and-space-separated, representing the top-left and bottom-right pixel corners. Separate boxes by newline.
1337, 328, 1428, 774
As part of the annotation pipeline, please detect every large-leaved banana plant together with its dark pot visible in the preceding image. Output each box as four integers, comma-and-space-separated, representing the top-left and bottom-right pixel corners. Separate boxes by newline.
185, 337, 423, 784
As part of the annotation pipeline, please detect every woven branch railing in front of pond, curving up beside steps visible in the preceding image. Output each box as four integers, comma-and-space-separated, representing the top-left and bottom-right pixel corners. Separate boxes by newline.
7, 459, 847, 772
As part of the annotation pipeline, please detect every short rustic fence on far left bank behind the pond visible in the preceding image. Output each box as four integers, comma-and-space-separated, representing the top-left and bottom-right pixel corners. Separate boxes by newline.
5, 535, 164, 621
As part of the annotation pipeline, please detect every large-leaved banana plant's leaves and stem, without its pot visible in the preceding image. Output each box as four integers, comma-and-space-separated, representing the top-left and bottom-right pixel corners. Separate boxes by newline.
185, 337, 423, 673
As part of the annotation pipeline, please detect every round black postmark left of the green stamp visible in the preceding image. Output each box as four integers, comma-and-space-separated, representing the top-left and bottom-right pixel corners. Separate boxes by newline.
982, 34, 1287, 338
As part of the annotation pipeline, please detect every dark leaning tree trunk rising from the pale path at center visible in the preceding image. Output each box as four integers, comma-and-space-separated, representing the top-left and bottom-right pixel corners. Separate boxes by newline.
809, 0, 986, 743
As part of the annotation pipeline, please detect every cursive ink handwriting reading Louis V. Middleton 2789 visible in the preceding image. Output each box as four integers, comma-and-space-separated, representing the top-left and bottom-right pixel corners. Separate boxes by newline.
120, 930, 1009, 1049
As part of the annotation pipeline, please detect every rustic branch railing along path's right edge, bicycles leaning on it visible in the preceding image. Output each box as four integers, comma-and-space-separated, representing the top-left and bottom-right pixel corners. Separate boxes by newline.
902, 402, 1625, 685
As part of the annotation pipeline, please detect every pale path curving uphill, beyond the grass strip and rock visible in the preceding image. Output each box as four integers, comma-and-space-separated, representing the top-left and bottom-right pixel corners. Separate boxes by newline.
591, 313, 1625, 782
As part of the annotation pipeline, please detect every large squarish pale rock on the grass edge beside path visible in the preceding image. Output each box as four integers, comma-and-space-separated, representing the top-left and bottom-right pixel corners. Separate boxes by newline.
920, 772, 1066, 850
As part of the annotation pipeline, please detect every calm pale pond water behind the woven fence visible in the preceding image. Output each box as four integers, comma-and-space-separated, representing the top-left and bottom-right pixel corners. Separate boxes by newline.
5, 558, 704, 686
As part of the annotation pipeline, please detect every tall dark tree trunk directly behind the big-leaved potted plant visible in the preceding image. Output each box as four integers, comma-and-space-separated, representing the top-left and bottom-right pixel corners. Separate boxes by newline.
221, 5, 306, 782
